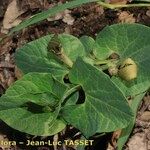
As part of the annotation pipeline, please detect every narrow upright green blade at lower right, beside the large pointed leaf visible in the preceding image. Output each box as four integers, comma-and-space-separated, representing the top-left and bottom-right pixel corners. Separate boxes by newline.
117, 93, 145, 150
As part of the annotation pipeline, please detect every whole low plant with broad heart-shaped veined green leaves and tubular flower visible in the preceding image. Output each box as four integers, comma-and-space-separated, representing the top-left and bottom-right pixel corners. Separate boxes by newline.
0, 24, 150, 149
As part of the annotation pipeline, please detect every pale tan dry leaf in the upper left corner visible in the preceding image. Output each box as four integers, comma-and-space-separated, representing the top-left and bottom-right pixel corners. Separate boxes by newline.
1, 0, 24, 33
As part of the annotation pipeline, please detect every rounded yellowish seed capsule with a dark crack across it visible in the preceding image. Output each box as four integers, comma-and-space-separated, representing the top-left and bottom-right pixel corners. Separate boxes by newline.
118, 58, 137, 81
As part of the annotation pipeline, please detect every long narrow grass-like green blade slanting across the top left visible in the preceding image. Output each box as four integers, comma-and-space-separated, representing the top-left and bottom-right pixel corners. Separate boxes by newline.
9, 0, 98, 35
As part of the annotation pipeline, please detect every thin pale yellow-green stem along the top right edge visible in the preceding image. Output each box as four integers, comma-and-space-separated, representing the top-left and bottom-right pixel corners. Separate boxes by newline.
97, 1, 150, 9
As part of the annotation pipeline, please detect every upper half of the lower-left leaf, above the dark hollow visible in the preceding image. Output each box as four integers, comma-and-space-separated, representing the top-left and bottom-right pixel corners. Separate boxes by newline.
1, 73, 66, 106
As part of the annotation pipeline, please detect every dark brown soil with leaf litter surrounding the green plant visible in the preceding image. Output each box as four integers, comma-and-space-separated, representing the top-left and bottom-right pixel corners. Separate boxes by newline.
0, 0, 150, 150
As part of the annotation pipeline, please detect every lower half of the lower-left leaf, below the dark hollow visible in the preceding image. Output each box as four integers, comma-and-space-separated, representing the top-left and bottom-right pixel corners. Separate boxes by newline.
0, 108, 66, 136
